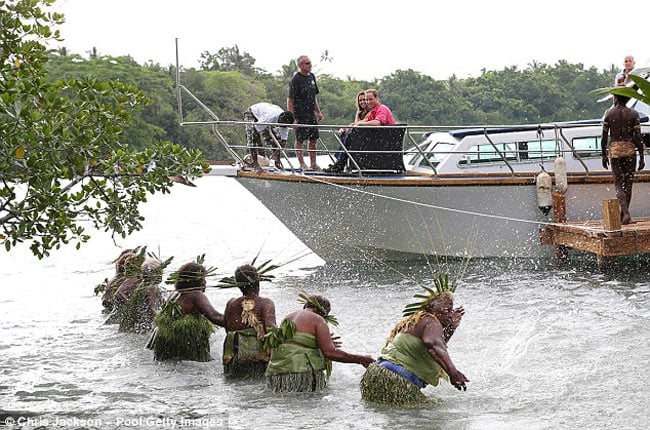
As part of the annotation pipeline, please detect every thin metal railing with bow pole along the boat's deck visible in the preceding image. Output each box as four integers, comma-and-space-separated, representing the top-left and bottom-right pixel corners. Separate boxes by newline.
171, 40, 650, 176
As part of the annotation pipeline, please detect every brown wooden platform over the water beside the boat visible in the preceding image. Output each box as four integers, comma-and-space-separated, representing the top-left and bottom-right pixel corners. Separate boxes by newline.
539, 218, 650, 257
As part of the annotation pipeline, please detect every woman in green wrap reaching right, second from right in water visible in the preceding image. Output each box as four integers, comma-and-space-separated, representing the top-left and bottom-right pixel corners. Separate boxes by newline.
266, 295, 374, 392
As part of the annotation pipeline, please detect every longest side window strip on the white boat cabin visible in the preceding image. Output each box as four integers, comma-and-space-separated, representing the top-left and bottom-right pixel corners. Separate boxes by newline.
458, 139, 559, 165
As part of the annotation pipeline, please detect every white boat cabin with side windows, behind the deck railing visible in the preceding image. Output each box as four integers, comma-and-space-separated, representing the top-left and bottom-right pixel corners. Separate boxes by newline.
404, 100, 650, 174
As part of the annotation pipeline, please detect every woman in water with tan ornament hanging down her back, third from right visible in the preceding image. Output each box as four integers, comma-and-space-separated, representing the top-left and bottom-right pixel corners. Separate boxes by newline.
222, 264, 275, 378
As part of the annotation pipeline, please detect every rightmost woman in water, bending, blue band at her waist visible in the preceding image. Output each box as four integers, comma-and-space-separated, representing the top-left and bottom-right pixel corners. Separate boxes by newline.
360, 291, 469, 406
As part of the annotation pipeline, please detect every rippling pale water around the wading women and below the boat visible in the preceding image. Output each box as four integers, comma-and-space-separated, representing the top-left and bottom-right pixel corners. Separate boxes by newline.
0, 177, 650, 430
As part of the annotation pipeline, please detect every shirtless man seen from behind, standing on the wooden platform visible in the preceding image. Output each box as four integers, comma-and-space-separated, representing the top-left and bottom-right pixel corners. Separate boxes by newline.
600, 94, 645, 224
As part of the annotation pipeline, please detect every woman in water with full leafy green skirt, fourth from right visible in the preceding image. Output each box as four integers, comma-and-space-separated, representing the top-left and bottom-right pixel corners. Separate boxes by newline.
147, 263, 224, 361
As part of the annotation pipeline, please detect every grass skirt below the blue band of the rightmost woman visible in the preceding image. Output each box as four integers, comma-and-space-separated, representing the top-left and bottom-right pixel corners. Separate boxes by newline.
359, 363, 426, 406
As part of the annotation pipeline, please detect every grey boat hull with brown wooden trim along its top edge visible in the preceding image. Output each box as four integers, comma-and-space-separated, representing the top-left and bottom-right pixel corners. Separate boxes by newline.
237, 175, 650, 261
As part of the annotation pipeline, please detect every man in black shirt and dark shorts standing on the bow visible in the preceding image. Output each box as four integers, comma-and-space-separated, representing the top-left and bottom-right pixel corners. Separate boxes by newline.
287, 55, 324, 170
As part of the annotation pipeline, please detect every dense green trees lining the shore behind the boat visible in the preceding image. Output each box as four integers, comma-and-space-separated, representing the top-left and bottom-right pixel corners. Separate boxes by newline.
48, 46, 618, 160
